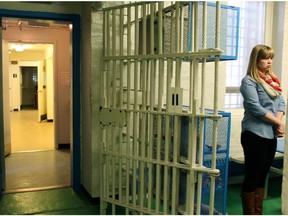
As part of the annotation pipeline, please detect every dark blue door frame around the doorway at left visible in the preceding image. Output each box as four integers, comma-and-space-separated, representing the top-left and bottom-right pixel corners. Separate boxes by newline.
0, 9, 81, 197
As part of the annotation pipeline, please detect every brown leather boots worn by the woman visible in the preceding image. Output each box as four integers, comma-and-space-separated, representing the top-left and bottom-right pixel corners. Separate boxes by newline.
241, 188, 264, 215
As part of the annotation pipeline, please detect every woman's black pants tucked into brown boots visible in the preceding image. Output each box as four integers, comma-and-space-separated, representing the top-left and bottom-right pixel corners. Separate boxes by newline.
241, 131, 277, 192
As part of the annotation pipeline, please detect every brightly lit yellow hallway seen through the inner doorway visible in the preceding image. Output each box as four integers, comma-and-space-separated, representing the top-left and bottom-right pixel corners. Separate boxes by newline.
9, 58, 55, 153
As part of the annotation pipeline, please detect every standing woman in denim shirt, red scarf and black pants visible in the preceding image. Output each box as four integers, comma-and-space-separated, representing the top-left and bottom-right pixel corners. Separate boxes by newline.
240, 45, 285, 215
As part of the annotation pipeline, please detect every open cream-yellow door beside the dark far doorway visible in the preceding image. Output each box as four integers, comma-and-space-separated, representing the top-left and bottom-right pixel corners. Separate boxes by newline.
37, 61, 47, 122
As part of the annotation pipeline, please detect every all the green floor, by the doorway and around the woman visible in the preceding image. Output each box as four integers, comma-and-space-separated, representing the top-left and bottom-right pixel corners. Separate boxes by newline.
0, 178, 282, 215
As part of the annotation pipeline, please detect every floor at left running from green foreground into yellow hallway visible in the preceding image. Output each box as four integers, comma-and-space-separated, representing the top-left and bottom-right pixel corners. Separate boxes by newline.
0, 109, 100, 215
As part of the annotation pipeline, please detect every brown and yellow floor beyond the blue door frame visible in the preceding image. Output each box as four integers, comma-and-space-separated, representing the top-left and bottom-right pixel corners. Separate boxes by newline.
4, 109, 71, 193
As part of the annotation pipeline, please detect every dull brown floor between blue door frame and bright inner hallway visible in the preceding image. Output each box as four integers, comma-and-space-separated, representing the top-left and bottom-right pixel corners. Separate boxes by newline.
4, 149, 71, 193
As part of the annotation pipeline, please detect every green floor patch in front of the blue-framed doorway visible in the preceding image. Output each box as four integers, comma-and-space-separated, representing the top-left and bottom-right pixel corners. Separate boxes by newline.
0, 188, 99, 215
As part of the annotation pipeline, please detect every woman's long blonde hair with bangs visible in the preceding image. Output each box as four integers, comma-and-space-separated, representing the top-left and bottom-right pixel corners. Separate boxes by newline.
247, 44, 275, 83
